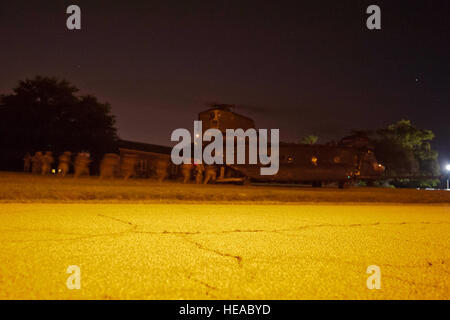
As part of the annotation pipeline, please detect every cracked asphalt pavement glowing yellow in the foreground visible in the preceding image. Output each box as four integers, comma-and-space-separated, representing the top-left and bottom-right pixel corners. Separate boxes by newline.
0, 203, 450, 299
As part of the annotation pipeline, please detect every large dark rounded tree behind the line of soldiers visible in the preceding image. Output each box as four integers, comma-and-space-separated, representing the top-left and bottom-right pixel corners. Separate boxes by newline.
0, 76, 117, 169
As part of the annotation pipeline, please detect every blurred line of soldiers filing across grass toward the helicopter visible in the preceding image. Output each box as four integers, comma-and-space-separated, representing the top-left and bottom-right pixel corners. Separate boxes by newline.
24, 151, 216, 184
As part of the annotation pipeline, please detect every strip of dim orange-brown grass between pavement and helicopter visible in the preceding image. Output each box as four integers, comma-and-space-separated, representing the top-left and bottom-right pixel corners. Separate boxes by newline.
0, 172, 450, 203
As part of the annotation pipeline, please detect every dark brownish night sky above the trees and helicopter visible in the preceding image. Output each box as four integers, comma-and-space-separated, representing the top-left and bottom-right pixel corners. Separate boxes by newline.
0, 0, 450, 168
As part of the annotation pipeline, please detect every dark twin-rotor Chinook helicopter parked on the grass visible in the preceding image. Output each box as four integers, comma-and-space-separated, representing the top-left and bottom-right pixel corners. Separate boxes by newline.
199, 104, 385, 188
